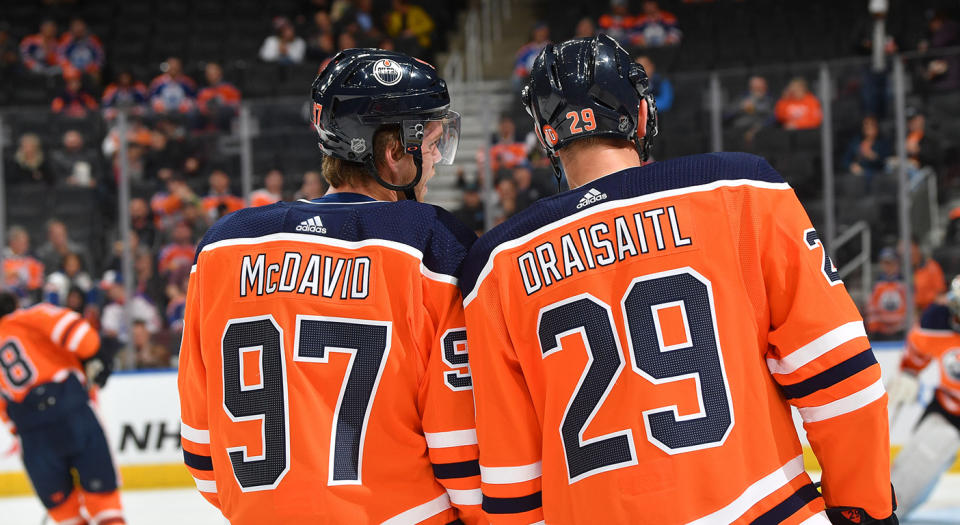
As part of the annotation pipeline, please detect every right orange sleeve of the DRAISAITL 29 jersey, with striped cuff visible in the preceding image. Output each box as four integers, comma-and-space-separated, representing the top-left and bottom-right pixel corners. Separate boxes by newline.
758, 183, 893, 519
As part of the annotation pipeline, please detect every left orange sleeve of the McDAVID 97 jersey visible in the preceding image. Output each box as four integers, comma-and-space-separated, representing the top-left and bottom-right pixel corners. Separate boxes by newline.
177, 267, 220, 509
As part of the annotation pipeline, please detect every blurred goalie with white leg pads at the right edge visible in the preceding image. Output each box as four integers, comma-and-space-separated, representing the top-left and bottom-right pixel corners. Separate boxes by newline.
890, 277, 960, 518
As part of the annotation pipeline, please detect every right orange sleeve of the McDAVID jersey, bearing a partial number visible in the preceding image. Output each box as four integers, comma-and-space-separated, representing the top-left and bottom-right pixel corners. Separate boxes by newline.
418, 277, 483, 524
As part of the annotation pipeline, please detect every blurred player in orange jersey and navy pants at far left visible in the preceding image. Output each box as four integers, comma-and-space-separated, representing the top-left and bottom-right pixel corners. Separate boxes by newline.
0, 292, 126, 525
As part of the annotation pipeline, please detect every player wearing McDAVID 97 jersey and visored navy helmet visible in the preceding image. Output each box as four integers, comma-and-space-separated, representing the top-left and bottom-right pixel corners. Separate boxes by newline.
179, 49, 482, 525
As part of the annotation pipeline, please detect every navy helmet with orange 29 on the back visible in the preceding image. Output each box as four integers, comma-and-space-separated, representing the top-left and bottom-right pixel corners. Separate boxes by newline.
521, 34, 657, 177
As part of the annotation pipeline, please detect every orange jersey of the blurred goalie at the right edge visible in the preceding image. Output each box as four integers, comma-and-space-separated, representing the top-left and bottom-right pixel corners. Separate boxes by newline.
900, 303, 960, 416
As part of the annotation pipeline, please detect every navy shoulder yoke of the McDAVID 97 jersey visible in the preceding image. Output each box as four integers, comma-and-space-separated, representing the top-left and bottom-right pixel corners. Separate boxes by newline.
194, 194, 477, 277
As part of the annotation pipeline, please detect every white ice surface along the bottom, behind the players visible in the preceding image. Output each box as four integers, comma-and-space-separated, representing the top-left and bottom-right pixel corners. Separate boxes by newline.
0, 474, 960, 525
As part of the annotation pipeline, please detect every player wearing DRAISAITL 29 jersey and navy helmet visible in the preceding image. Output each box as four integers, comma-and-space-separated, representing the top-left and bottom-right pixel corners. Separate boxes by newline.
460, 35, 896, 525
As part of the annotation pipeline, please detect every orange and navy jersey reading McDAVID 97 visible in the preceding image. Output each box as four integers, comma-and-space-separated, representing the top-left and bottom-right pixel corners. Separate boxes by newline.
180, 193, 476, 524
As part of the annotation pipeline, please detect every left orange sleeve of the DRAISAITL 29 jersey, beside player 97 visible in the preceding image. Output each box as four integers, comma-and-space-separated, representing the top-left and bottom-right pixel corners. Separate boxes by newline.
465, 275, 544, 524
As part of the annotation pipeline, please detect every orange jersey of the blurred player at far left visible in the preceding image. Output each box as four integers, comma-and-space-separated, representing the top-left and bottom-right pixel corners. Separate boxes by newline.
0, 304, 100, 427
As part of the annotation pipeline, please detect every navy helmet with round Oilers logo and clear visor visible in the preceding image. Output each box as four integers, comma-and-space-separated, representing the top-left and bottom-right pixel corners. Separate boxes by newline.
311, 49, 460, 198
